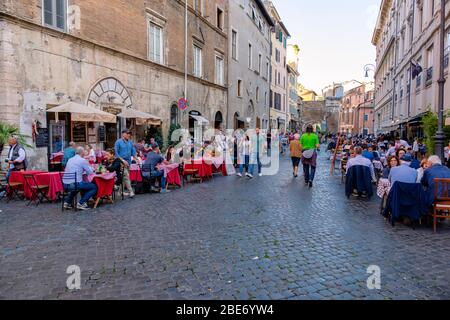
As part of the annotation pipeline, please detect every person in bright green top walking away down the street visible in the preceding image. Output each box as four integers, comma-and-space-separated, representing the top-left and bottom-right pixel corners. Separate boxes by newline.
300, 125, 320, 188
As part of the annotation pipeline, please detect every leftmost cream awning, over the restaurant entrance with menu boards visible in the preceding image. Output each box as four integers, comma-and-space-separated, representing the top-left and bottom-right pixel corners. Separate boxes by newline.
47, 102, 117, 123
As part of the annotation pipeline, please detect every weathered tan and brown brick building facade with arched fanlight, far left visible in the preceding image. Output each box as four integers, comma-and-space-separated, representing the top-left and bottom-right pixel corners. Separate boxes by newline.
0, 0, 228, 168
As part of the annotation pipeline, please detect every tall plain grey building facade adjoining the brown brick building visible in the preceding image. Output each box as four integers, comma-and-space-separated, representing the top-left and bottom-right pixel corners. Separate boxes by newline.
228, 0, 274, 129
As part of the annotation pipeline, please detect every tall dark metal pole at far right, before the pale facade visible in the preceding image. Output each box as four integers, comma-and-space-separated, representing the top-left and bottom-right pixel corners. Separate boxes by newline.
434, 0, 445, 159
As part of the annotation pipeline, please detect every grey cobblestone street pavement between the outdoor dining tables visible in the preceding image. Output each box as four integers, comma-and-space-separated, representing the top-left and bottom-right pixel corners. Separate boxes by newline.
0, 150, 450, 300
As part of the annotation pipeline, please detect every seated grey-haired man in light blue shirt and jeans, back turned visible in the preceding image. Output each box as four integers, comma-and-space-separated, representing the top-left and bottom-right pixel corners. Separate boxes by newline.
63, 147, 97, 210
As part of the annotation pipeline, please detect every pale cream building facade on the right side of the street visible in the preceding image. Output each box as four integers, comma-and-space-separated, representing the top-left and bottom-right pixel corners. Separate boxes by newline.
372, 0, 450, 138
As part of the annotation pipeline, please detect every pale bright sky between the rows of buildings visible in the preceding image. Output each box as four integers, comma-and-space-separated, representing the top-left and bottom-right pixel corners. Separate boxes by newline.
272, 0, 381, 94
